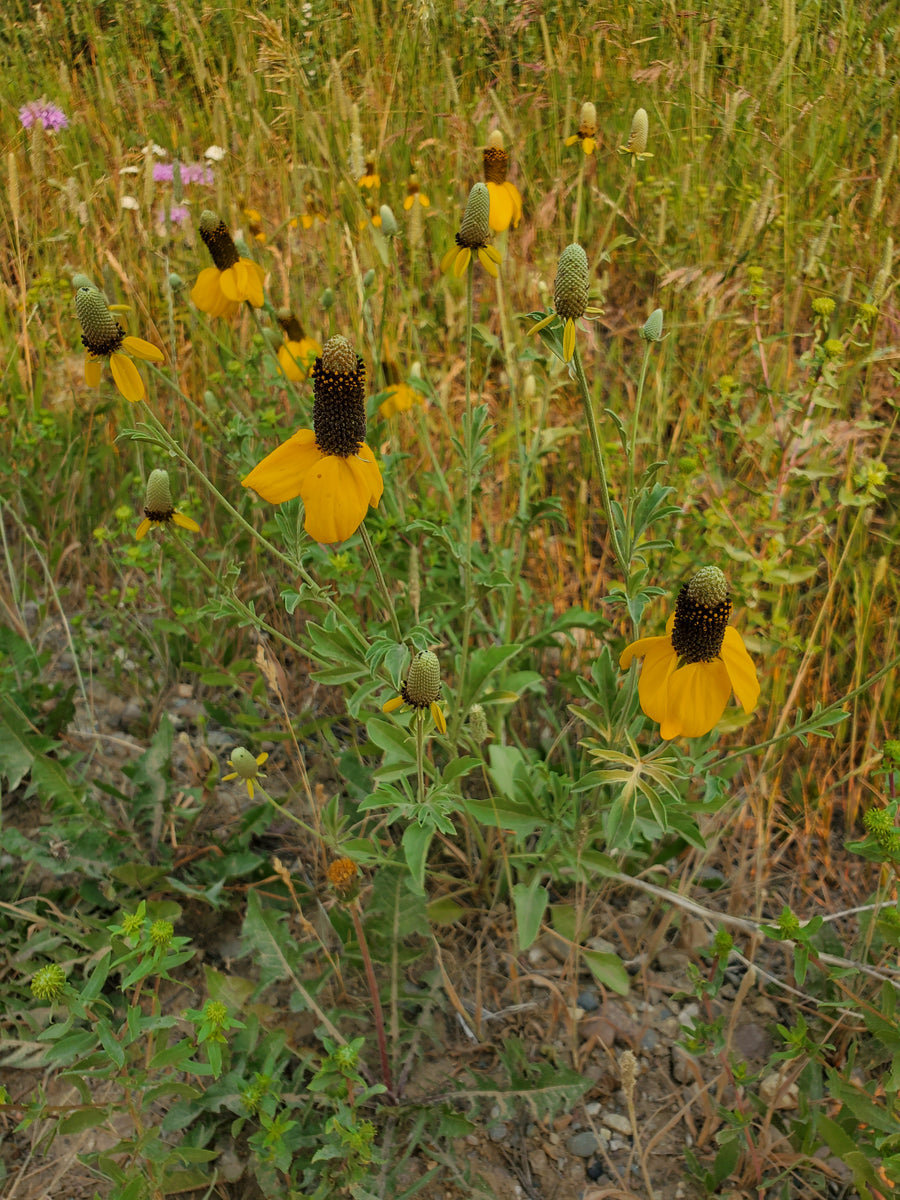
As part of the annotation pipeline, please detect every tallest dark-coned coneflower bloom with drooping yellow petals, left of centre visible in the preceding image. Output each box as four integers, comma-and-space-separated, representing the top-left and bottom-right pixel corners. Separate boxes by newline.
241, 337, 384, 545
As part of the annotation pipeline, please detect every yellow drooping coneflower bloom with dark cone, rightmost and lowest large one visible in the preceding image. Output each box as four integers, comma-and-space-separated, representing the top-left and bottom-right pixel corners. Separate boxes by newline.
619, 566, 760, 739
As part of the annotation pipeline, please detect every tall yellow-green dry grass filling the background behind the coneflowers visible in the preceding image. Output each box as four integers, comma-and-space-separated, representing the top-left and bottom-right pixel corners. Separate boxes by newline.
0, 0, 900, 1195
